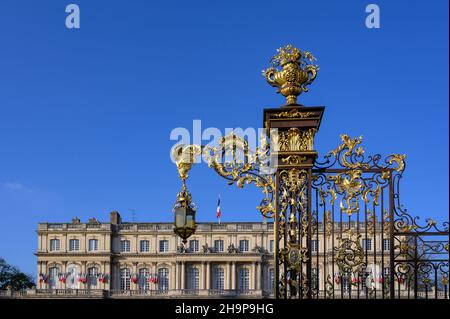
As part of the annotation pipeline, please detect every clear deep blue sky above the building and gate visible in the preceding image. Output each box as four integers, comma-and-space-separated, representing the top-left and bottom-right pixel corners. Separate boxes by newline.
0, 0, 449, 274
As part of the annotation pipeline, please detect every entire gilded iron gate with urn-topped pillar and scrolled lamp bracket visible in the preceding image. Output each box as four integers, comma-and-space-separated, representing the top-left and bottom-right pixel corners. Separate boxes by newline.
174, 45, 449, 299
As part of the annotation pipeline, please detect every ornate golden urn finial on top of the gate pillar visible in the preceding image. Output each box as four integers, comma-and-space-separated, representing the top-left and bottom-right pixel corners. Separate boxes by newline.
263, 44, 319, 105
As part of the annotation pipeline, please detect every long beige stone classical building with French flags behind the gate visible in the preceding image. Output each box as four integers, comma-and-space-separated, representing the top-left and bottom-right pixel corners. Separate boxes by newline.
36, 212, 390, 297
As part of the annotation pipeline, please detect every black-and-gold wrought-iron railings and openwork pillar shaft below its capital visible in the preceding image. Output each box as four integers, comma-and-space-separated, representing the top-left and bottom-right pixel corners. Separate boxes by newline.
275, 135, 449, 299
